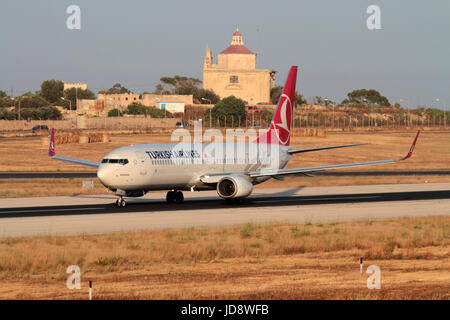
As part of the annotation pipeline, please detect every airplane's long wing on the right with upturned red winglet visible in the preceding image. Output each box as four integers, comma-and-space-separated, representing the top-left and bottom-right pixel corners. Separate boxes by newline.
247, 130, 420, 178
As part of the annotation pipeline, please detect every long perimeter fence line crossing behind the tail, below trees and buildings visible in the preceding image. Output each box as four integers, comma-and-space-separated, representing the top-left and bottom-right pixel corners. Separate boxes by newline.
0, 108, 450, 133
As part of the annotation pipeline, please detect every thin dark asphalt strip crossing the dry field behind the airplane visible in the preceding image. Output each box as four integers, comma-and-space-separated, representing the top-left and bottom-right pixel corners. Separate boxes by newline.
0, 170, 450, 179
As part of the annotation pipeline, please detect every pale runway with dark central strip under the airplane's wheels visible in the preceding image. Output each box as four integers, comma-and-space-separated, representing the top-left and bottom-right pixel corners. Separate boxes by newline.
0, 183, 450, 237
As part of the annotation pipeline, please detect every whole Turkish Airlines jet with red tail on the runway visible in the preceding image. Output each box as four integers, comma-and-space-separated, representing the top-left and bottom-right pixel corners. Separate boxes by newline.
48, 66, 420, 207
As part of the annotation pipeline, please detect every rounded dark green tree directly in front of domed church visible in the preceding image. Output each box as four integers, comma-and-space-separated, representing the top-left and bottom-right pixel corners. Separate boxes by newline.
203, 96, 246, 126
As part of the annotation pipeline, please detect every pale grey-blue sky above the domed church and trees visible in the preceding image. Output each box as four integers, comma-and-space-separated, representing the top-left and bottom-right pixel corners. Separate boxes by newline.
0, 0, 450, 110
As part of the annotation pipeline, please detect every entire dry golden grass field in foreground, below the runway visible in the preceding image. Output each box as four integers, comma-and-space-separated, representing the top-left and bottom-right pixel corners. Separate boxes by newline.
0, 217, 450, 299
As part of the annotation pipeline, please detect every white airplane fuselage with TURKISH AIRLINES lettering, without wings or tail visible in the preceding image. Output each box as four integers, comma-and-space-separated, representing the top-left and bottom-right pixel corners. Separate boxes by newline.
97, 142, 291, 196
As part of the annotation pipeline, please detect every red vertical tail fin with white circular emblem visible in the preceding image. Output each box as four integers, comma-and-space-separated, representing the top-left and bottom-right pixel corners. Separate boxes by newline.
254, 66, 297, 146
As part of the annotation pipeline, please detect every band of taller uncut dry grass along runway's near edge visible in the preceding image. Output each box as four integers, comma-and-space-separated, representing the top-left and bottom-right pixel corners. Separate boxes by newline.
0, 217, 450, 278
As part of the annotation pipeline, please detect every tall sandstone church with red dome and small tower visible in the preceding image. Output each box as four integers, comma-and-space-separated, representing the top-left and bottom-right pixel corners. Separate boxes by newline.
202, 29, 275, 105
